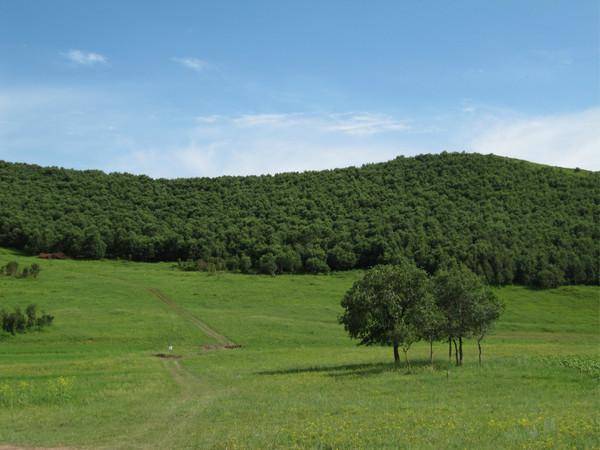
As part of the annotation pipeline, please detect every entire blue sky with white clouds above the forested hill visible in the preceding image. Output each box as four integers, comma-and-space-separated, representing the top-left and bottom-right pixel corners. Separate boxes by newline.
0, 0, 600, 178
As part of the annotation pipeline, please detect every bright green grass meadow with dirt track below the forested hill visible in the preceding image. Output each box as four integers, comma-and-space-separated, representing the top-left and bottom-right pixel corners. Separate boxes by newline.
0, 249, 600, 449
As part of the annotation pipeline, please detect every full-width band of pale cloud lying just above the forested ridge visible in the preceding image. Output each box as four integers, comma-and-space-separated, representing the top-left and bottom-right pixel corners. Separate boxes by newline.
0, 82, 600, 178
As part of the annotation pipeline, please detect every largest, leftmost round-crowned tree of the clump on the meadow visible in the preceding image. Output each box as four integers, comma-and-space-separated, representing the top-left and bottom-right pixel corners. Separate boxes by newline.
339, 262, 430, 371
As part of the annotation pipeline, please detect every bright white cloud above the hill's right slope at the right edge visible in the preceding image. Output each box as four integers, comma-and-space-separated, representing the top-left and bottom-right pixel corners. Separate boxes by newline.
469, 108, 600, 171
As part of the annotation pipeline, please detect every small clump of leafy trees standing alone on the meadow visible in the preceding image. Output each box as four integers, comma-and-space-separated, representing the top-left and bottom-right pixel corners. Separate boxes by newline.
339, 261, 504, 371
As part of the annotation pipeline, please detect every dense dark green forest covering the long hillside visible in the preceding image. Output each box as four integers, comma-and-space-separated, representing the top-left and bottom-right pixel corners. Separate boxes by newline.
0, 152, 600, 287
